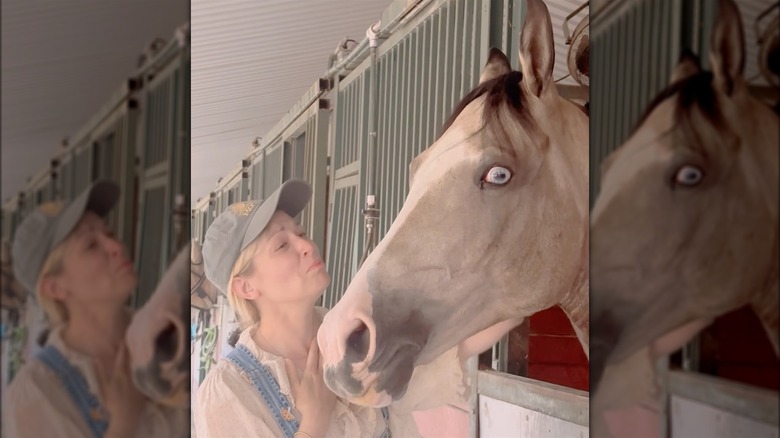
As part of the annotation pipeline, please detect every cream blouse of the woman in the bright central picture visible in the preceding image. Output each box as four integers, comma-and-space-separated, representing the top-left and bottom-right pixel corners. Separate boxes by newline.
193, 307, 467, 438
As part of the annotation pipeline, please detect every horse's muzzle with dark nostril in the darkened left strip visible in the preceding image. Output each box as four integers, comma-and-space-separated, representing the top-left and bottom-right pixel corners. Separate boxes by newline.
125, 243, 190, 408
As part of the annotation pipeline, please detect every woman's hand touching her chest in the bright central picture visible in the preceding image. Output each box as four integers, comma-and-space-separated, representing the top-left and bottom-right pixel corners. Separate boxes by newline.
284, 338, 336, 438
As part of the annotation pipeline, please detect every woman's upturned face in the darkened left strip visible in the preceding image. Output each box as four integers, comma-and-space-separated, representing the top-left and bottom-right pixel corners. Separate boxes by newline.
55, 212, 138, 302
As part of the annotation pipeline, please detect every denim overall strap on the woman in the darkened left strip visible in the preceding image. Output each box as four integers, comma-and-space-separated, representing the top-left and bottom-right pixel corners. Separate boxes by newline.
36, 345, 108, 438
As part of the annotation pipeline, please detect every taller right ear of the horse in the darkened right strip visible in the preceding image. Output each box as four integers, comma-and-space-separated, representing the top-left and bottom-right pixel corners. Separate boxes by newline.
710, 0, 745, 95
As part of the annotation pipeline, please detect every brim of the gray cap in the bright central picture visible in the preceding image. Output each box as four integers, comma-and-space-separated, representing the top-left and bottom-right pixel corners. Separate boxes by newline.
241, 179, 311, 251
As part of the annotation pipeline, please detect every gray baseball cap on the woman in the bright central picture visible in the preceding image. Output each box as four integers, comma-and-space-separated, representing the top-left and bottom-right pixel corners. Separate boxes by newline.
203, 179, 311, 294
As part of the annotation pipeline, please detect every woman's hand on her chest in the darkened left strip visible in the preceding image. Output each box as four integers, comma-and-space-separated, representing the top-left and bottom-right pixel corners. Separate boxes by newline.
95, 343, 146, 438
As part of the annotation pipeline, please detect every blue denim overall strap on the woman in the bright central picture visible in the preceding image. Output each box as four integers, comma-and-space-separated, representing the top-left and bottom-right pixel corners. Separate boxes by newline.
226, 345, 300, 438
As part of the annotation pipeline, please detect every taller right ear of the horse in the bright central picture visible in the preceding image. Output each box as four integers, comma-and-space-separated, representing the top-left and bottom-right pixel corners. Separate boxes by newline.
520, 0, 555, 96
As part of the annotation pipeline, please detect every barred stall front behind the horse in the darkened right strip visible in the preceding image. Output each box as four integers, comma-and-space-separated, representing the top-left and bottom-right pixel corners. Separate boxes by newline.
590, 0, 683, 207
